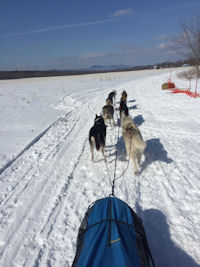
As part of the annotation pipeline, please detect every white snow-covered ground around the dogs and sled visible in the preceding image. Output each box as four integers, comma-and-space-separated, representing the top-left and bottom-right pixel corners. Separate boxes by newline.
0, 70, 200, 267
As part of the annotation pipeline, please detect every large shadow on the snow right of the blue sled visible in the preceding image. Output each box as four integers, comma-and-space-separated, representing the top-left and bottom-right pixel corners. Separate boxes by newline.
136, 203, 199, 267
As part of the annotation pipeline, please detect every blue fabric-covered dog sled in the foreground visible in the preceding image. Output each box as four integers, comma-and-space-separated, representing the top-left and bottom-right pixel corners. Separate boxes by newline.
72, 196, 155, 267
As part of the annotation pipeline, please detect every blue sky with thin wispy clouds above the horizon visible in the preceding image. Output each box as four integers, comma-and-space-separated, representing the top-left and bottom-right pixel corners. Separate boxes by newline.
0, 0, 200, 70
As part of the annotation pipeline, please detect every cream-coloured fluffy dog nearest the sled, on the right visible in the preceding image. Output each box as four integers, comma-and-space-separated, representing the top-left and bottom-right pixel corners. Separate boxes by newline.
121, 117, 146, 174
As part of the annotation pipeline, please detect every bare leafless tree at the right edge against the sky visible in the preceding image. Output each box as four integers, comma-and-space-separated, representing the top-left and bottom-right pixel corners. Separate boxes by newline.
172, 16, 200, 92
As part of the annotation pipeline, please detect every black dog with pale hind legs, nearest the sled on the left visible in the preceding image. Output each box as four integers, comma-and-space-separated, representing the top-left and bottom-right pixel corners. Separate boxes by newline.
89, 115, 106, 161
